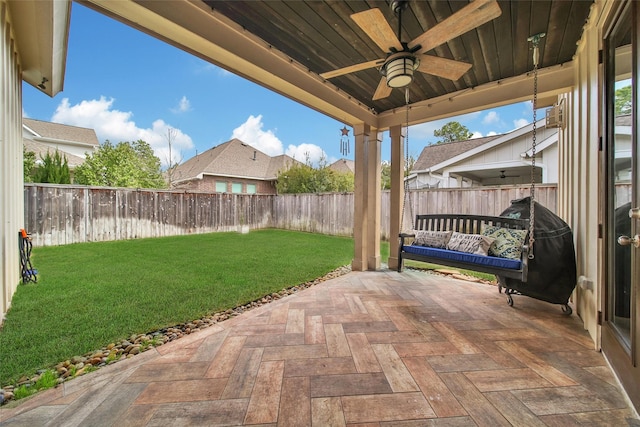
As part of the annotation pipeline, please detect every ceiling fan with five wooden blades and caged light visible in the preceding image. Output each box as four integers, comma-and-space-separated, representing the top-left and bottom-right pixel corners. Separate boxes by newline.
320, 0, 502, 101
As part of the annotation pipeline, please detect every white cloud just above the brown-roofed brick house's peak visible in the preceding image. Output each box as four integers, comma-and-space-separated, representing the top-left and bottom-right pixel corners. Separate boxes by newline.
231, 114, 324, 165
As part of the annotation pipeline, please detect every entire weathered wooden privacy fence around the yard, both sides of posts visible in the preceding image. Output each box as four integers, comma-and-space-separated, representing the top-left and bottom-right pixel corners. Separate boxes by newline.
23, 184, 556, 246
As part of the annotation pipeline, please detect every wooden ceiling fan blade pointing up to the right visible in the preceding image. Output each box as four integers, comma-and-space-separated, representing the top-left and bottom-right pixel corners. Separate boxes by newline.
409, 0, 502, 54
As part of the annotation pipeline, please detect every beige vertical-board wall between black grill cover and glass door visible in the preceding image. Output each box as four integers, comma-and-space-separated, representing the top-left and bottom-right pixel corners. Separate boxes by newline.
558, 0, 611, 348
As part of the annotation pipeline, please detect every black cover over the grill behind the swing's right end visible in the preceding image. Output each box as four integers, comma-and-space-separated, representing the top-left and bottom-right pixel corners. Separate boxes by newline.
498, 197, 577, 304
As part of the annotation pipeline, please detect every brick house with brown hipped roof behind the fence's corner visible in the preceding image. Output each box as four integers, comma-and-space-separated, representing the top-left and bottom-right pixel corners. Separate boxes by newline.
171, 139, 299, 194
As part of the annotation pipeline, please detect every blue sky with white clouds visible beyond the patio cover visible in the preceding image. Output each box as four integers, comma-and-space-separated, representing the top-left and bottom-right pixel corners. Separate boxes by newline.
23, 3, 532, 168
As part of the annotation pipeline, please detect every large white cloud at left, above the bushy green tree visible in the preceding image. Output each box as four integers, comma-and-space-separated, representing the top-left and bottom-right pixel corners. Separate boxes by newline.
51, 96, 193, 166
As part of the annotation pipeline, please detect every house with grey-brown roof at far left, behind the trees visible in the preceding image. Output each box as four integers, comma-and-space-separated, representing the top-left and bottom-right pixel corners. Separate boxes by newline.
22, 118, 100, 170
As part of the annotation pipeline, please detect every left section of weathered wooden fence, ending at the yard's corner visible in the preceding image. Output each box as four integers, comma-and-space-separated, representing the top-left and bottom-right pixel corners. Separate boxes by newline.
24, 184, 273, 246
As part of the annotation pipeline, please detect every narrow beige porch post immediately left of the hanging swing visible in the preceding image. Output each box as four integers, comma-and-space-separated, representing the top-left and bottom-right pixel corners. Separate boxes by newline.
389, 125, 402, 270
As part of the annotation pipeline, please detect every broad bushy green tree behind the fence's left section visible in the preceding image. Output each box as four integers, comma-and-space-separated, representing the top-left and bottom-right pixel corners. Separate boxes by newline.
75, 140, 167, 188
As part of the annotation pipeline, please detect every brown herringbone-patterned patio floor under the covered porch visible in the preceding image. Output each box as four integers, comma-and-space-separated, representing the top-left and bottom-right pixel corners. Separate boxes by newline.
0, 270, 640, 426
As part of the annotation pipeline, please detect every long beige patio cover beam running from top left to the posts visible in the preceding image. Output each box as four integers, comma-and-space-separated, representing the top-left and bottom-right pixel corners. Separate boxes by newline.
79, 0, 376, 126
